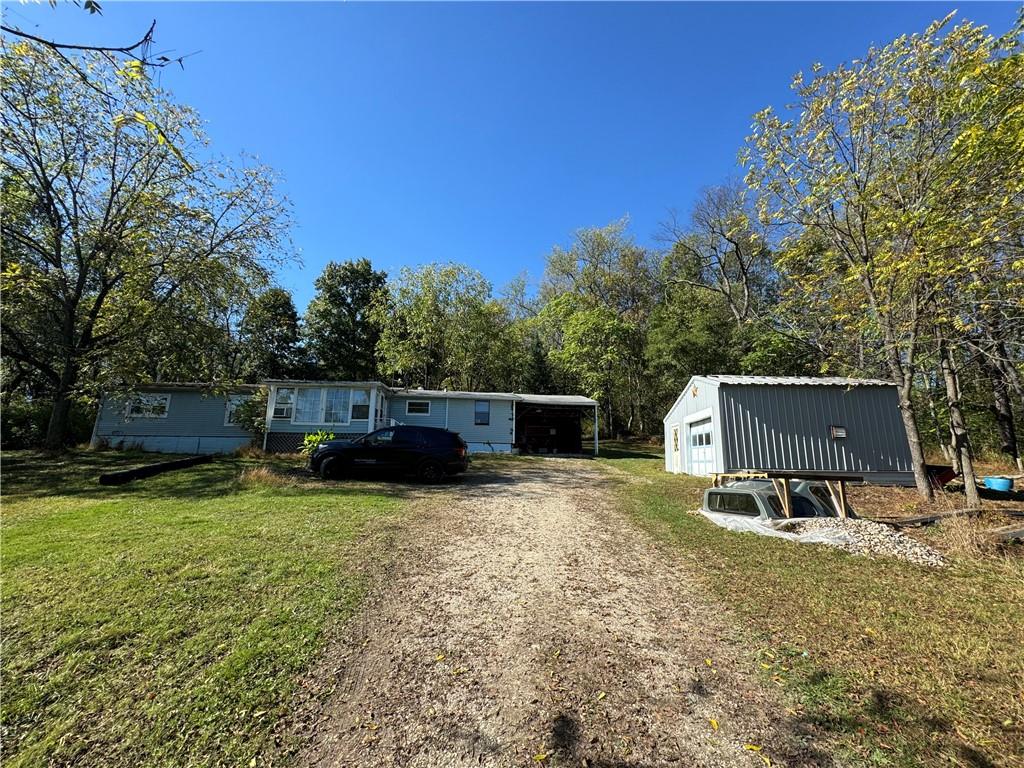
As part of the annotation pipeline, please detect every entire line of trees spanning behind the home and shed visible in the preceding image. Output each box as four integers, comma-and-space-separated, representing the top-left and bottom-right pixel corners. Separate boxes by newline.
3, 15, 1024, 505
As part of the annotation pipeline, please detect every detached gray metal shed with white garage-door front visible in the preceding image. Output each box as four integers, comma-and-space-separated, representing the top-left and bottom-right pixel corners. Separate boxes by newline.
664, 376, 913, 485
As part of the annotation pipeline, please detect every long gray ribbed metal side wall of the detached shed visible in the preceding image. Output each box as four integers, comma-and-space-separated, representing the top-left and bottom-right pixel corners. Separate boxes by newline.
720, 384, 910, 474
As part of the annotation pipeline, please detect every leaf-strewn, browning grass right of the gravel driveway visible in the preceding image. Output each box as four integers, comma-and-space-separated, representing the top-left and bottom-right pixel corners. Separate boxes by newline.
602, 446, 1024, 767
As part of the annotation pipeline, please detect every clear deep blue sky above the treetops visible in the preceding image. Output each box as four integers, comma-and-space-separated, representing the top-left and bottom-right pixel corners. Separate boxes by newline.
4, 1, 1017, 310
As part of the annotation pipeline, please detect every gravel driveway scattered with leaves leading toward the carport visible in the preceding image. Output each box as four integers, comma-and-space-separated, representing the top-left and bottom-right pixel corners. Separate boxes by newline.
299, 460, 830, 768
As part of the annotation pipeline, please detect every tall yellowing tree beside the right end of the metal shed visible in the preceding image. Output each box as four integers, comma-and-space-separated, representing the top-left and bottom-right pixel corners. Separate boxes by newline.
743, 12, 1019, 498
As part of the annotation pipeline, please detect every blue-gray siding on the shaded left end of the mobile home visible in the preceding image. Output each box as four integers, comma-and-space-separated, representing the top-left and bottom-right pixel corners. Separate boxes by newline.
94, 390, 253, 453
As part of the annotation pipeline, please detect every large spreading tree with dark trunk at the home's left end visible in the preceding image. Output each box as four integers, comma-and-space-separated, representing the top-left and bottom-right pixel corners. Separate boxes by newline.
0, 43, 288, 449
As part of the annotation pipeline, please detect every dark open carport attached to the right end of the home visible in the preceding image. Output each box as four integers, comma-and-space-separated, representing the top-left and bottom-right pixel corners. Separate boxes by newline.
513, 394, 598, 456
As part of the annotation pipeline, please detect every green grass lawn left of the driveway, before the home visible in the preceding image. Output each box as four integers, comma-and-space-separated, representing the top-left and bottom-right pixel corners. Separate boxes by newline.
0, 452, 402, 766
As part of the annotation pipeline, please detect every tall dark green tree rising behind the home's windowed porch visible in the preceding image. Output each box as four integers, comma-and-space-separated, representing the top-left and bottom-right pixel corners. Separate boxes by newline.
304, 259, 387, 381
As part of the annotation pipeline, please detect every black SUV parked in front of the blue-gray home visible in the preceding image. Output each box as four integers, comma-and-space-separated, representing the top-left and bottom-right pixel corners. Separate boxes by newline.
309, 426, 469, 482
